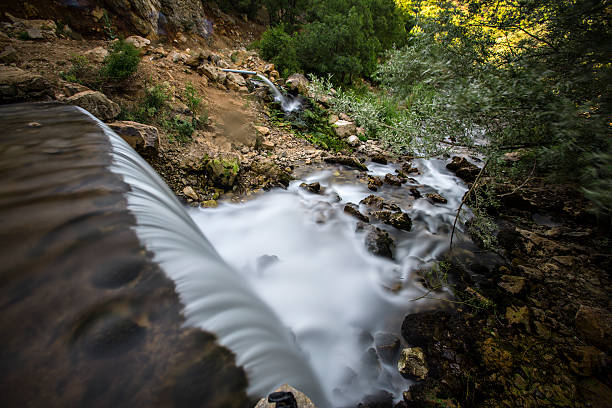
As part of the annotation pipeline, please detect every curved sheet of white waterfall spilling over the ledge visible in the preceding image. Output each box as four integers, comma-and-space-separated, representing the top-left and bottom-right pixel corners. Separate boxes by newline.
82, 110, 328, 407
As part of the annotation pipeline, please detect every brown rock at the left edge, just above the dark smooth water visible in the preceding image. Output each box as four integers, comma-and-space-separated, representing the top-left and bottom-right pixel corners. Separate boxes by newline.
0, 66, 51, 103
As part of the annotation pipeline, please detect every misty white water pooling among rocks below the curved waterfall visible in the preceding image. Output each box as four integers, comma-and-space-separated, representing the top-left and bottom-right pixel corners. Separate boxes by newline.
190, 160, 466, 406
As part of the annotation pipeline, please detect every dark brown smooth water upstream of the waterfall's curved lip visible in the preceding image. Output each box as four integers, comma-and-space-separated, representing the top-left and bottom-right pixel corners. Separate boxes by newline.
0, 103, 251, 407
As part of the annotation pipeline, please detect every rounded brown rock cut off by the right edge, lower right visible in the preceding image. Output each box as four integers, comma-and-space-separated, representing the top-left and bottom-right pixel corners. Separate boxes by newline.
576, 305, 612, 353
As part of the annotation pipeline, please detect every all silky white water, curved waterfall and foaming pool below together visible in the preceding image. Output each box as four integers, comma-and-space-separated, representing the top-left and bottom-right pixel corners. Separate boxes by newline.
86, 104, 466, 408
